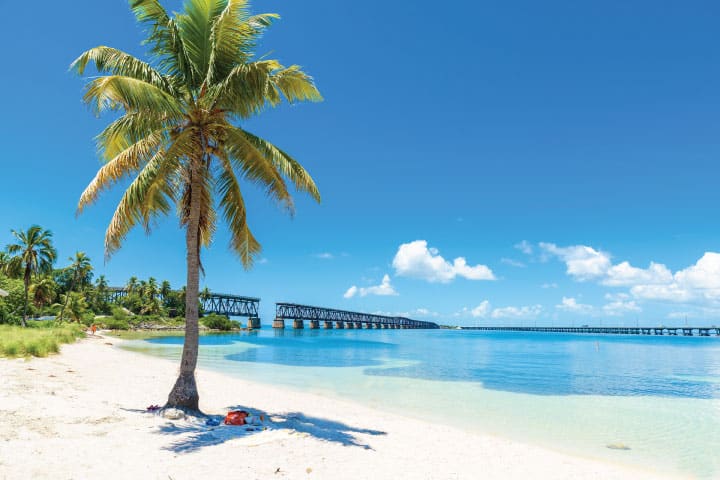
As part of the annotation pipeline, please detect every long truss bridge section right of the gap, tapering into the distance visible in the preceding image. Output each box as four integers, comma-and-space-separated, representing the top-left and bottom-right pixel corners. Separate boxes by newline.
273, 303, 440, 329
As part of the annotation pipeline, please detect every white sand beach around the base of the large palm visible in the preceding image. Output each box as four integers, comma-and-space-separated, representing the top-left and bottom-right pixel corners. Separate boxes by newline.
0, 337, 676, 480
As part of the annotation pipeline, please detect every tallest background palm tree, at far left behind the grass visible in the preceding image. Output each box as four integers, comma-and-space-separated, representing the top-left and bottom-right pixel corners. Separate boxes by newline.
7, 225, 57, 327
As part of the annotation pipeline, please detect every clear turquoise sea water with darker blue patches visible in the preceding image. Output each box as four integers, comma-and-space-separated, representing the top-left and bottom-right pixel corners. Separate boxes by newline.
127, 329, 720, 478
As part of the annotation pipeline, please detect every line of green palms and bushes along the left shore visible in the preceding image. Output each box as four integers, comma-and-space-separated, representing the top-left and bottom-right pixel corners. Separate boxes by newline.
0, 225, 205, 326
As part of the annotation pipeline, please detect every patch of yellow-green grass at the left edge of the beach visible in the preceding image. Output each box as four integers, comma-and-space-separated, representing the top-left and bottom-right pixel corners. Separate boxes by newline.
0, 322, 84, 358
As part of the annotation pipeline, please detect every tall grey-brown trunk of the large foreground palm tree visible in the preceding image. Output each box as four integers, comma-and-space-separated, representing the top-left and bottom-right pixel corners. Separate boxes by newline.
165, 166, 201, 410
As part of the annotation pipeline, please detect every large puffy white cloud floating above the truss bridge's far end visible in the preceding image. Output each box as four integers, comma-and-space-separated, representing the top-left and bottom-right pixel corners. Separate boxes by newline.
393, 240, 495, 283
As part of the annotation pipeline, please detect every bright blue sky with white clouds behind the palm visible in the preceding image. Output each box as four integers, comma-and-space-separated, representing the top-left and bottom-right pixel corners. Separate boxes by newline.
0, 0, 720, 324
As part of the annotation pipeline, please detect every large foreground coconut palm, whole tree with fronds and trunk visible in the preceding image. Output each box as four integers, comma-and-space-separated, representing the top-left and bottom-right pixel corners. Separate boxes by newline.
73, 0, 321, 410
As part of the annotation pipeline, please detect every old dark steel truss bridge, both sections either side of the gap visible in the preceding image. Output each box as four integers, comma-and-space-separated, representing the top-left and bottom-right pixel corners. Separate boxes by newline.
103, 287, 440, 329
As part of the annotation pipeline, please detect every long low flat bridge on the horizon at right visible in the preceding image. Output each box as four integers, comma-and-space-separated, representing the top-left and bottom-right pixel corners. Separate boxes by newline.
460, 326, 720, 337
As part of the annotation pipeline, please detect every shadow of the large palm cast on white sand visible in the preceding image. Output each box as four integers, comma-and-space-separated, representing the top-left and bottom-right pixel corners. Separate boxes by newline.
158, 405, 386, 453
